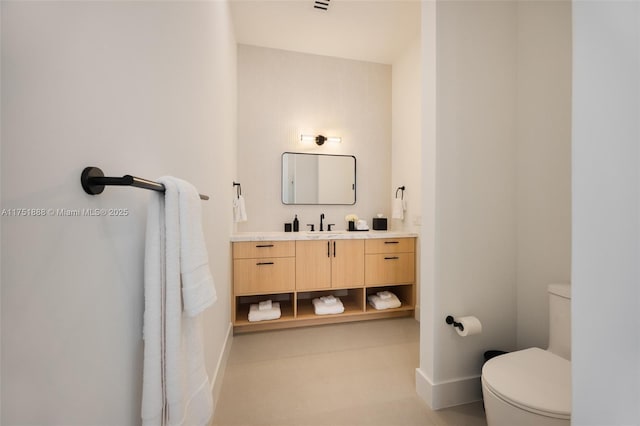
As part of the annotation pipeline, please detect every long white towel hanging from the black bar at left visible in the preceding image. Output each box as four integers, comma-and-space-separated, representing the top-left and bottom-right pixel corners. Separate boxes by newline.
141, 177, 216, 426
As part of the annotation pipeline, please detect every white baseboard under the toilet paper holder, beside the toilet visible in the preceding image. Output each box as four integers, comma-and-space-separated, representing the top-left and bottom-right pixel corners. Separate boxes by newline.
416, 368, 482, 410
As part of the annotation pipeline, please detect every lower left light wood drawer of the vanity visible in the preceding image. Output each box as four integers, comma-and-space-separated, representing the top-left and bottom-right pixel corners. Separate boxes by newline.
233, 257, 296, 295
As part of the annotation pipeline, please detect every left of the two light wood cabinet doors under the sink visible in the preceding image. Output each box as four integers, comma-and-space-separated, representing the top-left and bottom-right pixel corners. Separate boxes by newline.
296, 241, 331, 290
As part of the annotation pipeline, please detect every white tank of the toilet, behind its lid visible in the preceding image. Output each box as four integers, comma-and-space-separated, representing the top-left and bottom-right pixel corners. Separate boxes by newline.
547, 284, 571, 361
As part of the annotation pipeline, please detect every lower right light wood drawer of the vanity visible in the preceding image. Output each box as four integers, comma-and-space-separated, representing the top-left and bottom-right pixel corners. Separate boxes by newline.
364, 253, 415, 285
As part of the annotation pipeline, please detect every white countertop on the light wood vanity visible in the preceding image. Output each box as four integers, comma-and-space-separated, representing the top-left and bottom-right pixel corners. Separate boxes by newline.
231, 231, 418, 242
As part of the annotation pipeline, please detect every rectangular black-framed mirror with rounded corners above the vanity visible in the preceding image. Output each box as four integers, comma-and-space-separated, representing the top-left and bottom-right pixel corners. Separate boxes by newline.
282, 152, 356, 204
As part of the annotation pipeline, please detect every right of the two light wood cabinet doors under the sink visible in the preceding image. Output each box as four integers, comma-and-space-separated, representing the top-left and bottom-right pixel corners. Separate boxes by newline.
331, 240, 364, 287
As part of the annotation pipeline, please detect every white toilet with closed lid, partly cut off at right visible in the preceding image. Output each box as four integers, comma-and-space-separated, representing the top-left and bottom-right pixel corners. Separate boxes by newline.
482, 284, 571, 426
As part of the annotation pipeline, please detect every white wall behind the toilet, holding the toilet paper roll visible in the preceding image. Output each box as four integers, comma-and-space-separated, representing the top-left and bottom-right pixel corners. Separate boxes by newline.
416, 1, 570, 408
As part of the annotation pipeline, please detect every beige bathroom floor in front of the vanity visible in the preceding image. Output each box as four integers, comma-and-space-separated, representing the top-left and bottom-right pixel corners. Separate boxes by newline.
213, 318, 486, 426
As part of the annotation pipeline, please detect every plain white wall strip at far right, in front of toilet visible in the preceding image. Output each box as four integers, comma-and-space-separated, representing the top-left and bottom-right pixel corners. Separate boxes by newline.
572, 2, 640, 425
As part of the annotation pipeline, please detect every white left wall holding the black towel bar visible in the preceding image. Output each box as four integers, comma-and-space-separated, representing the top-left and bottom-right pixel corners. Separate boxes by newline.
1, 2, 236, 425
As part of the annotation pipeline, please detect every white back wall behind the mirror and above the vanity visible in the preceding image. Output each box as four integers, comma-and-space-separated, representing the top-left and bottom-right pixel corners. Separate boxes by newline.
237, 45, 391, 231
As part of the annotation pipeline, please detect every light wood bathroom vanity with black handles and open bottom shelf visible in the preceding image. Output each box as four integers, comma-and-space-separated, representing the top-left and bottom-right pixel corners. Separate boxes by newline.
231, 231, 417, 333
